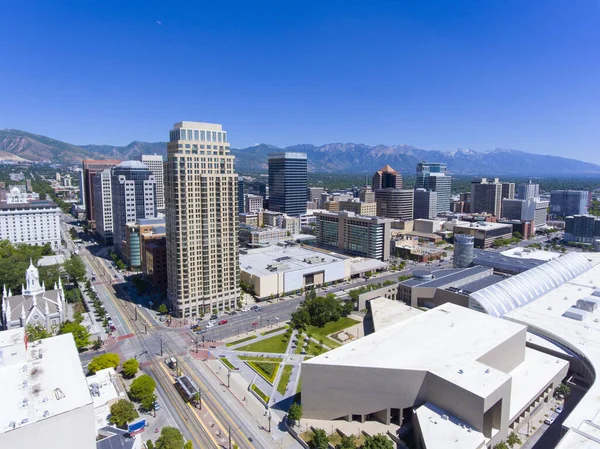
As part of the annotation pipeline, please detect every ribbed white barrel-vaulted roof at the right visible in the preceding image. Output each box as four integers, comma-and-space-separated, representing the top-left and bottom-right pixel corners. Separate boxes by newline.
469, 253, 592, 317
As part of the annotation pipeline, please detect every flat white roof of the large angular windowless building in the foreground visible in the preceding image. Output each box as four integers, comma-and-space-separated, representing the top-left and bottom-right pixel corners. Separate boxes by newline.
303, 303, 525, 397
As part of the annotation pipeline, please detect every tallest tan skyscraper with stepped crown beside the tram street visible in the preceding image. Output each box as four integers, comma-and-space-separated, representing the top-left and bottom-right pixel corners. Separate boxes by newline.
164, 122, 239, 317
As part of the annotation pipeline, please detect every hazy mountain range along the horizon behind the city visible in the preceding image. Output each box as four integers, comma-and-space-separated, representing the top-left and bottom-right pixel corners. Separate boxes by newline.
0, 129, 600, 176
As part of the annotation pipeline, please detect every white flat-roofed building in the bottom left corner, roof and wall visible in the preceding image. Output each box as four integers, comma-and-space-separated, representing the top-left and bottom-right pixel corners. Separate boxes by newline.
0, 328, 96, 449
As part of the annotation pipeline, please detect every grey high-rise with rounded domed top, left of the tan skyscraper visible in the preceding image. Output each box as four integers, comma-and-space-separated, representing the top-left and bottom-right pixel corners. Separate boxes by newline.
111, 161, 156, 263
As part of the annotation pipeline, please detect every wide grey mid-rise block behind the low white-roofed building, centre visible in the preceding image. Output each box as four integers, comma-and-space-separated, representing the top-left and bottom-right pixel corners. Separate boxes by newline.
314, 212, 392, 261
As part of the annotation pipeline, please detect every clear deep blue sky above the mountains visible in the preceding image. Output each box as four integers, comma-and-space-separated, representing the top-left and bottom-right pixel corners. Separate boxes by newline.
0, 0, 600, 163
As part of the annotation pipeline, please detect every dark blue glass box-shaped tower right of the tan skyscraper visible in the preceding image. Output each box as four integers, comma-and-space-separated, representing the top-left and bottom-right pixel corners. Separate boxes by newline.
269, 152, 308, 217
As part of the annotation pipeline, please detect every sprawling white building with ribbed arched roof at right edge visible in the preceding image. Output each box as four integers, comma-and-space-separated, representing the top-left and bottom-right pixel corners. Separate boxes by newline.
466, 253, 600, 449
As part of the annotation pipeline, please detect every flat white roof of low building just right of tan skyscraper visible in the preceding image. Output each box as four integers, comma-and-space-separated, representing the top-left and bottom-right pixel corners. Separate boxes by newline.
240, 246, 345, 276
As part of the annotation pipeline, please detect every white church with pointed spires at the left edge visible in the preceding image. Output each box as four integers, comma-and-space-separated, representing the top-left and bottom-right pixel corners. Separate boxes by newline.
1, 261, 67, 331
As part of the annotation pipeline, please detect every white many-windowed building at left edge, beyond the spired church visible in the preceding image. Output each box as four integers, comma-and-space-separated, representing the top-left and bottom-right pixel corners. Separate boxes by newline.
0, 188, 61, 251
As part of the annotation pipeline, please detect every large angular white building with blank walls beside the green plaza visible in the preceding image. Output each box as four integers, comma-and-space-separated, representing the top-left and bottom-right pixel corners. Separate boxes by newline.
302, 303, 569, 449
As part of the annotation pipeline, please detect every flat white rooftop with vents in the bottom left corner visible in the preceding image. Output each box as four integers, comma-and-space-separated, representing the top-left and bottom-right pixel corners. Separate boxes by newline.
0, 328, 92, 433
